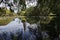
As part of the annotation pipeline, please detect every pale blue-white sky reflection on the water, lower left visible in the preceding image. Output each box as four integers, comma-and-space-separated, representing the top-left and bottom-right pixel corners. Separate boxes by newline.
0, 18, 41, 40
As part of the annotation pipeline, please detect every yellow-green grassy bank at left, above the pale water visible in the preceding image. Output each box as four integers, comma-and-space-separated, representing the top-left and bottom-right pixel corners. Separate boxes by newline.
0, 16, 25, 25
